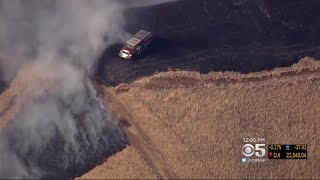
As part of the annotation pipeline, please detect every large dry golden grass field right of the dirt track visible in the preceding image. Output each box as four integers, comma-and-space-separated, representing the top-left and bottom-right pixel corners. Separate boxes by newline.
84, 58, 320, 179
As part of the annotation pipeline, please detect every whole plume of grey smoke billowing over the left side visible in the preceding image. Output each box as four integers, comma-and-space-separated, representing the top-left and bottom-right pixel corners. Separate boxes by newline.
0, 0, 128, 178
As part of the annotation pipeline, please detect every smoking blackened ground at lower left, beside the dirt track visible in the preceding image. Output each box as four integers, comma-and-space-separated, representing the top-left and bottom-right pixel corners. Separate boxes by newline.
0, 82, 129, 179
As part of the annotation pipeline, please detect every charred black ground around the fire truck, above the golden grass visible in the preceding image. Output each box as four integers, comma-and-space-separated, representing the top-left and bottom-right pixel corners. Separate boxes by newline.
96, 0, 320, 86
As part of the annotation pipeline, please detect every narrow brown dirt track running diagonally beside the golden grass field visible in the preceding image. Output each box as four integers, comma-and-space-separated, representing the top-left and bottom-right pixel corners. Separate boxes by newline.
96, 85, 178, 179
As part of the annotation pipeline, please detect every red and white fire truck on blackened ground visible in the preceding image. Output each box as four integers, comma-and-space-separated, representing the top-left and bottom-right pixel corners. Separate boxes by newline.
119, 30, 153, 60
